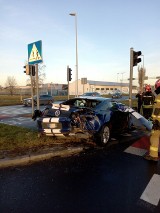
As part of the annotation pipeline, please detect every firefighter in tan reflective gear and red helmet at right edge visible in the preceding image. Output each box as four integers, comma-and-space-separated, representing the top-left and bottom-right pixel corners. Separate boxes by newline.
144, 79, 160, 161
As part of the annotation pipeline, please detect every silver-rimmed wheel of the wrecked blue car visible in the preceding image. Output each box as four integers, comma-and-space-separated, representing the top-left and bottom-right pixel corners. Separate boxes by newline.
99, 124, 111, 146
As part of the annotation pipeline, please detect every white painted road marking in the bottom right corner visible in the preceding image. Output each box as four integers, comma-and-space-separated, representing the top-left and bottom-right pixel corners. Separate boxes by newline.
140, 174, 160, 206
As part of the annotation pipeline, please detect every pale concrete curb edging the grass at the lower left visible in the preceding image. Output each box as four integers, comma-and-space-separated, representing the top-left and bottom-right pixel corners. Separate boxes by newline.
0, 147, 83, 169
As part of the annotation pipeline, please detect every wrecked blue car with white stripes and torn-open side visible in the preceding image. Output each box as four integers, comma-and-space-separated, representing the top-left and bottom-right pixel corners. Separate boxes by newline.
33, 97, 151, 146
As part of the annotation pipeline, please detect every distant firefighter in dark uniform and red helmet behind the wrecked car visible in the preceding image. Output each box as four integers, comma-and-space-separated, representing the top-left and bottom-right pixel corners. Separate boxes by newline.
142, 84, 155, 119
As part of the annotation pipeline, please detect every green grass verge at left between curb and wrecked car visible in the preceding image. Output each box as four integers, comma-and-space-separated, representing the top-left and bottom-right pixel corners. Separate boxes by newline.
0, 124, 84, 158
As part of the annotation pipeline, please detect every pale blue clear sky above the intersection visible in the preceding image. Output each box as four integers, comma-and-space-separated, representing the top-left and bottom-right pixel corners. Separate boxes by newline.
0, 0, 160, 86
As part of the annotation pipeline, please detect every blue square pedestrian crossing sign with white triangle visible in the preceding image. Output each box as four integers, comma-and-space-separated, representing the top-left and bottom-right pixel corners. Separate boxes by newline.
28, 41, 43, 64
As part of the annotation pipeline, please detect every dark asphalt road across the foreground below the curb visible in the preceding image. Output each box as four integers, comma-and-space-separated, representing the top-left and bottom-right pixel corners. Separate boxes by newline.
0, 133, 160, 213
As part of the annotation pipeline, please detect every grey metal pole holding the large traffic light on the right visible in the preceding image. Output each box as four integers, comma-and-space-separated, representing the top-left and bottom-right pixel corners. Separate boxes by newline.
129, 48, 133, 107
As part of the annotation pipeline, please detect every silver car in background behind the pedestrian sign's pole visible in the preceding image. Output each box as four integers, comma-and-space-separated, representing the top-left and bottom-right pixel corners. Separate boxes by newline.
22, 95, 54, 106
